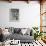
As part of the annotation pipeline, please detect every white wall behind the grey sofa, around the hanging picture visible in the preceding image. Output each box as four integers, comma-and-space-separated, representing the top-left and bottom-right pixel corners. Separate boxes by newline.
0, 2, 40, 27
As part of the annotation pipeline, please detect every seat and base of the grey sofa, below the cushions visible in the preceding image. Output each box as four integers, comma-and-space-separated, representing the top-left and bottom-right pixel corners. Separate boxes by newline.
9, 33, 34, 43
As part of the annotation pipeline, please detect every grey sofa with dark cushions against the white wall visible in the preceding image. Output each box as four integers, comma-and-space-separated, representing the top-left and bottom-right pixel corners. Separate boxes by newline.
5, 27, 34, 43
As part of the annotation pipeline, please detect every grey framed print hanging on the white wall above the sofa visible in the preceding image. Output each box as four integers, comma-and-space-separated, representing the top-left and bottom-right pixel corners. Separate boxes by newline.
10, 9, 19, 22
